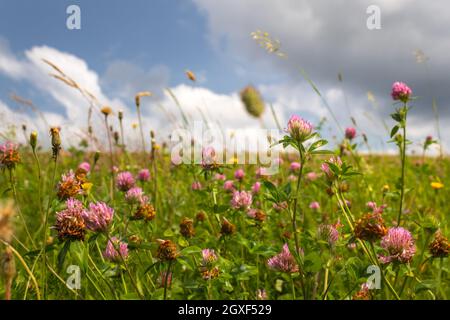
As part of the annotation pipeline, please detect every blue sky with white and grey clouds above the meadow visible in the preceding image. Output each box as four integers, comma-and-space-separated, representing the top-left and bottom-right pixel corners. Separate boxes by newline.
0, 0, 450, 151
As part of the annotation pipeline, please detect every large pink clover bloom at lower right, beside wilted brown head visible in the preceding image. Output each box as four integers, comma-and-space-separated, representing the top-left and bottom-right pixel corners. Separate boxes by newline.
379, 227, 416, 263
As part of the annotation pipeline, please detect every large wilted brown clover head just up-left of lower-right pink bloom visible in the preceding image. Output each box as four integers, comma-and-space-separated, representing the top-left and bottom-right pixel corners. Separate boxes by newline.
355, 212, 387, 241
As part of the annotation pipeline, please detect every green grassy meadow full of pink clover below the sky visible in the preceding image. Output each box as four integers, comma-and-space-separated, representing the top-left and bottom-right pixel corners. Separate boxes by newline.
0, 54, 450, 300
